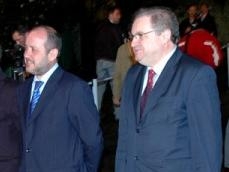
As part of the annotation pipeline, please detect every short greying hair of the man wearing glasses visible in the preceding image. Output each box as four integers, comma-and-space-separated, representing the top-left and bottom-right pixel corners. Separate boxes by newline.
133, 6, 179, 43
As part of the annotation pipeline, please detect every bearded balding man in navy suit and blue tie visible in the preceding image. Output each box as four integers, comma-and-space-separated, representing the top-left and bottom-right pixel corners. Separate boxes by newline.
19, 26, 102, 172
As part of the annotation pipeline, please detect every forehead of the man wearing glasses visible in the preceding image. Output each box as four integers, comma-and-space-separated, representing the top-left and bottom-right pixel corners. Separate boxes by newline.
131, 16, 152, 34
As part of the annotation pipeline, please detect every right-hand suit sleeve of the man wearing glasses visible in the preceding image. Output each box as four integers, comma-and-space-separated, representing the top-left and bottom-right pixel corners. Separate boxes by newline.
187, 67, 222, 172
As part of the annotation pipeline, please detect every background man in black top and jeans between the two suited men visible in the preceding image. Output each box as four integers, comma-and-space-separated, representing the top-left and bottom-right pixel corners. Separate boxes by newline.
94, 5, 124, 115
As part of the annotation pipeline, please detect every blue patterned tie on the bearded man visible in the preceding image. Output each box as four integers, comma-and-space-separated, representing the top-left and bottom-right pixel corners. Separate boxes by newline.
30, 81, 44, 114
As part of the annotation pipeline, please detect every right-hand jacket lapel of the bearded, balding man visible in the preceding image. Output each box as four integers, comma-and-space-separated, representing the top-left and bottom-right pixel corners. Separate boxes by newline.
27, 68, 63, 125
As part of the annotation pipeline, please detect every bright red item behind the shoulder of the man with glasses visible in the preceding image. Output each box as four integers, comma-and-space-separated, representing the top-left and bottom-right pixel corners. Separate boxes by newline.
178, 29, 223, 68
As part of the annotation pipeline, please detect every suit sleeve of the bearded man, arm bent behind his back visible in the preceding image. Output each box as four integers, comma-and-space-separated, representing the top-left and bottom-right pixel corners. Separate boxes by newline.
68, 82, 103, 172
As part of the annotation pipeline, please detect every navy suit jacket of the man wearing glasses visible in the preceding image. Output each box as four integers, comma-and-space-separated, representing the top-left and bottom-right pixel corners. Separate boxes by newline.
116, 49, 222, 172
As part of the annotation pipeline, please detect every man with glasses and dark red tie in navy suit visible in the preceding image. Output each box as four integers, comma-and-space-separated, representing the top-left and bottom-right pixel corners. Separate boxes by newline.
115, 7, 222, 172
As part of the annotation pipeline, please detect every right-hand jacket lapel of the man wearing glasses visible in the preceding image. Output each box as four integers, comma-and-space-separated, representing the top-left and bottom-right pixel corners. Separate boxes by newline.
143, 49, 182, 121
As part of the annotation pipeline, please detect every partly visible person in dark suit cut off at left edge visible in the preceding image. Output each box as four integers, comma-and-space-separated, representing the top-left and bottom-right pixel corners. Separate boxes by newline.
0, 69, 21, 172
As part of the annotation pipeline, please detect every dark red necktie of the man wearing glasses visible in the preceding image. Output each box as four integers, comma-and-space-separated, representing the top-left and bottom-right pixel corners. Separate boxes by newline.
140, 69, 155, 118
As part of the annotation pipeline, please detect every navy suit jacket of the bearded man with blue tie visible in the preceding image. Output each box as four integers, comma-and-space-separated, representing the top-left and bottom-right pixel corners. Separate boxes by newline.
19, 68, 102, 172
